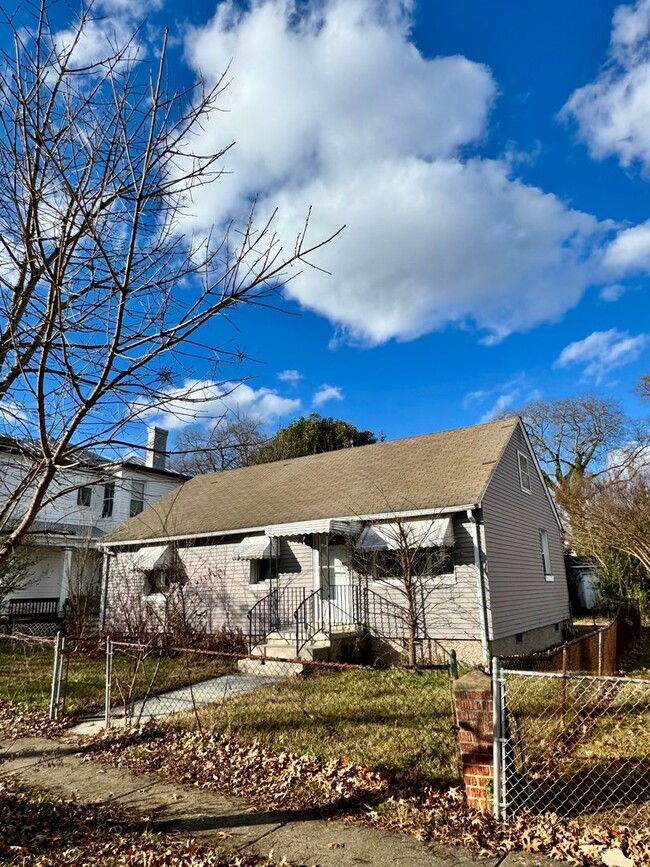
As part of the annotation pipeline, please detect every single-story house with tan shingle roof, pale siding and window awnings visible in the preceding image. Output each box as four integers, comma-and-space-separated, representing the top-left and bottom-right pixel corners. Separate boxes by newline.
102, 418, 570, 661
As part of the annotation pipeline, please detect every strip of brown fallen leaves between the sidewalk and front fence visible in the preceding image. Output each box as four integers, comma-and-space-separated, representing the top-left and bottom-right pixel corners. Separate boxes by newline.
85, 727, 650, 867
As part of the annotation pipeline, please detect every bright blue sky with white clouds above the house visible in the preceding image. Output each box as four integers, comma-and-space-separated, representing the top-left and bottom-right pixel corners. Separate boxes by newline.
34, 0, 650, 439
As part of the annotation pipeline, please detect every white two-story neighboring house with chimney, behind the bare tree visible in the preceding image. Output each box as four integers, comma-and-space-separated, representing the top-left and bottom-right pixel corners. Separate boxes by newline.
0, 428, 187, 612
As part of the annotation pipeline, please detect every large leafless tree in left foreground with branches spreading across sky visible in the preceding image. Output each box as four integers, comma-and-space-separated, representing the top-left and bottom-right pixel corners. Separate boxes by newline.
0, 0, 340, 564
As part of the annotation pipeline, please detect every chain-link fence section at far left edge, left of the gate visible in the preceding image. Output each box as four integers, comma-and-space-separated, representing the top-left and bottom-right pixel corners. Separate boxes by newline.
0, 633, 57, 711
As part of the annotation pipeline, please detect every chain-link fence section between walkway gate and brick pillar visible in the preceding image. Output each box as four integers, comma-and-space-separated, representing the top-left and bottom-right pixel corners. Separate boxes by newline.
109, 642, 459, 783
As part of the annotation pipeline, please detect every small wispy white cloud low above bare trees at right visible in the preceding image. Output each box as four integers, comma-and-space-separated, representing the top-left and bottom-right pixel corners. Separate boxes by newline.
555, 328, 649, 384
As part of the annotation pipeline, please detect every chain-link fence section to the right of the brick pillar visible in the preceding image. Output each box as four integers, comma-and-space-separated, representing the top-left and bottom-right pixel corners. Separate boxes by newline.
495, 671, 650, 826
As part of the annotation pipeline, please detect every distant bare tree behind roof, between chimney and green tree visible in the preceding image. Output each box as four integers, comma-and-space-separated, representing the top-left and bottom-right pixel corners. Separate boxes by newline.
172, 416, 267, 476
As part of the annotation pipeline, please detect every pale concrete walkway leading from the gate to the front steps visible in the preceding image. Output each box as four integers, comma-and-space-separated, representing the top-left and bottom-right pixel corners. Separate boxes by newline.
69, 674, 286, 735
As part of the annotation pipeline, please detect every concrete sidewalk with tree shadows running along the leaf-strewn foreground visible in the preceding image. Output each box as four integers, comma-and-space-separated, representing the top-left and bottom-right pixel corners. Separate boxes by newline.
0, 738, 558, 867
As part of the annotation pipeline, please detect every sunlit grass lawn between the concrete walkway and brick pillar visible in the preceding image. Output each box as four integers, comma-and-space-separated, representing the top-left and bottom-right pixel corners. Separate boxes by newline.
177, 670, 458, 784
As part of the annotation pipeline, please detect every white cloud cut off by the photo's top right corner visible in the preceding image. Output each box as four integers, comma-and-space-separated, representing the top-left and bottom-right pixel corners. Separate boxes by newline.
561, 0, 650, 172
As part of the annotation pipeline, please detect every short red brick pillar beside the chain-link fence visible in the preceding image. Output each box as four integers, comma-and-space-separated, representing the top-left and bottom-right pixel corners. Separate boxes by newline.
454, 671, 494, 812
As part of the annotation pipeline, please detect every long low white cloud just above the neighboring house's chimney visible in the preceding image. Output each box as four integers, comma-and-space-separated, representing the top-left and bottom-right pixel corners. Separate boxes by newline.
141, 380, 300, 430
